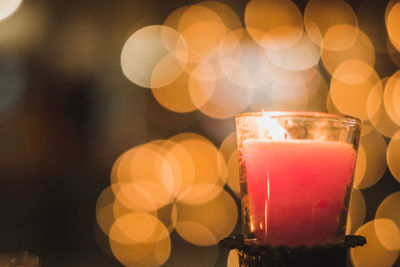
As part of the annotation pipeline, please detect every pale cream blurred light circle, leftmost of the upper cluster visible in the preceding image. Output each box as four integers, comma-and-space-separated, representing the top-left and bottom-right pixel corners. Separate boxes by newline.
121, 25, 188, 88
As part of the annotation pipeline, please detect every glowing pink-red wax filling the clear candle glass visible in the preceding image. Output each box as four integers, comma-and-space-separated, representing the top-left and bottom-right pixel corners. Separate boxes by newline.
239, 139, 357, 246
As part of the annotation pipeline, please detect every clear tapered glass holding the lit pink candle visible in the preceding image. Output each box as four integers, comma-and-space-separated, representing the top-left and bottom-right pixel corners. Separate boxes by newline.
236, 111, 361, 246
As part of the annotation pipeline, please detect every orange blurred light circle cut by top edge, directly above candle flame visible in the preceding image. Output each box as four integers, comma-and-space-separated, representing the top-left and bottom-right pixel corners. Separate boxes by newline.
244, 0, 303, 49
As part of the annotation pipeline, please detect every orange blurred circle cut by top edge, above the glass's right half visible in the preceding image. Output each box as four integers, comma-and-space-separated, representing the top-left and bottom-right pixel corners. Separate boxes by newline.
304, 0, 357, 50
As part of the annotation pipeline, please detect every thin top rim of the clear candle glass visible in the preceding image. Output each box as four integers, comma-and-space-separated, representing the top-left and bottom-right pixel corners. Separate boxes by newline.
235, 110, 361, 126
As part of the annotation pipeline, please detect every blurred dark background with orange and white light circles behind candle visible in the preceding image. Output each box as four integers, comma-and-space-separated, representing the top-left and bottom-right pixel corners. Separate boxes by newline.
0, 0, 400, 267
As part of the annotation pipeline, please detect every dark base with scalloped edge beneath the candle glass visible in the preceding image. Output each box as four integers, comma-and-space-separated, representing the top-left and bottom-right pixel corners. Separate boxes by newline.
220, 235, 367, 267
